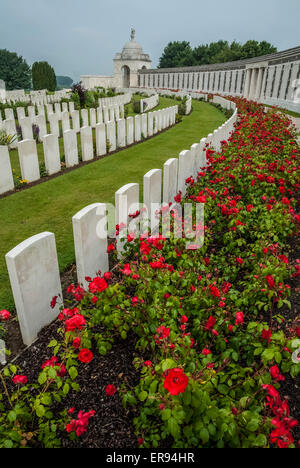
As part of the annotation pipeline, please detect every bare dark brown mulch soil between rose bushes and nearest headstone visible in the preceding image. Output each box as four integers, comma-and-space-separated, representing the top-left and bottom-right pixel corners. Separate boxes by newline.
7, 322, 139, 448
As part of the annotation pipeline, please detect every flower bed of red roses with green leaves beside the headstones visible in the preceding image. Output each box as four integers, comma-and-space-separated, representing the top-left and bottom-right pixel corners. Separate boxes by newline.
0, 100, 300, 448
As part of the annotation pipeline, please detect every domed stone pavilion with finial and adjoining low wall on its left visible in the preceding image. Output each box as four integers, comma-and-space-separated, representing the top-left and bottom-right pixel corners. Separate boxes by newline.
81, 29, 152, 89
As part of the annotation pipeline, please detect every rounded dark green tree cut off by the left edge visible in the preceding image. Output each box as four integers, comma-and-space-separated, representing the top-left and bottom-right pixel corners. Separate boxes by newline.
0, 49, 31, 91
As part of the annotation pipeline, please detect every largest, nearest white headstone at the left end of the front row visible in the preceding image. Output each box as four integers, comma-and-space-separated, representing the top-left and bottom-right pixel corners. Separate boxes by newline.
5, 232, 62, 346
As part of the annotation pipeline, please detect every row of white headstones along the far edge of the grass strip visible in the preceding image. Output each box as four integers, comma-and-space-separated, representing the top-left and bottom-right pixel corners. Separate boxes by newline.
0, 106, 178, 194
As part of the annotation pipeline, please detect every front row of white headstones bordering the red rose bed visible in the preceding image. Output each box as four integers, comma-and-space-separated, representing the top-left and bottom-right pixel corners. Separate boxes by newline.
2, 97, 237, 345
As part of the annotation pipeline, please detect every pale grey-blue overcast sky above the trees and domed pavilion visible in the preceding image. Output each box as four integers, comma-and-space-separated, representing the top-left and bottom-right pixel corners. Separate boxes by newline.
0, 0, 300, 81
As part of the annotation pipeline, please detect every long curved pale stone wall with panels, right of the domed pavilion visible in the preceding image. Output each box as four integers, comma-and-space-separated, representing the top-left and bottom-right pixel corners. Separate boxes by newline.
139, 47, 300, 113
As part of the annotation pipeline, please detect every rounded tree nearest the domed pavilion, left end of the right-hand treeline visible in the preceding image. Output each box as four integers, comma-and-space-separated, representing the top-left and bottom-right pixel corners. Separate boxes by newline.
158, 41, 194, 68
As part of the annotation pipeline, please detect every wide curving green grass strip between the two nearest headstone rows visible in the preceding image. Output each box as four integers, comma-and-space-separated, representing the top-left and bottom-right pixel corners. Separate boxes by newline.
0, 100, 226, 310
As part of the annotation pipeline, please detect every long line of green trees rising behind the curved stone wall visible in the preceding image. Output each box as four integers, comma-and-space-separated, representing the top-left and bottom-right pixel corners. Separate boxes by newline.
159, 40, 277, 68
